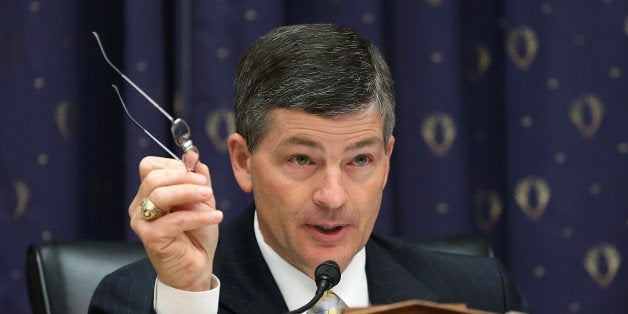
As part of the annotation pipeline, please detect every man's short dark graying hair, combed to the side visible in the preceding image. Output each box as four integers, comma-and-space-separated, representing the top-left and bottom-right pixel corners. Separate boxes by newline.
235, 24, 395, 152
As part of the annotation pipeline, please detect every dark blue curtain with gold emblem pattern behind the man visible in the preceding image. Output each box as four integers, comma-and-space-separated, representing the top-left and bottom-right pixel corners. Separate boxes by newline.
0, 0, 628, 313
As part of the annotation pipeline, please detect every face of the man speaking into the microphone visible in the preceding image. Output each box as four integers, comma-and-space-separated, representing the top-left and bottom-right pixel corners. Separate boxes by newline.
248, 109, 394, 277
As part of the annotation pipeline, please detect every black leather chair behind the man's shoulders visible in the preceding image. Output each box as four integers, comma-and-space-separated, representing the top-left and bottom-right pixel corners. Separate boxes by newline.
26, 236, 493, 314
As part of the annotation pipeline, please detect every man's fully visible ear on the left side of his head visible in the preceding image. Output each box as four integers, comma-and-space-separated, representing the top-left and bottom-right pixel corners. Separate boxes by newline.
227, 133, 253, 193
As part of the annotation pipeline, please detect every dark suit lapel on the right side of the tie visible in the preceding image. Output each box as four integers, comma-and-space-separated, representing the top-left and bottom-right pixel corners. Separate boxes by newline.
366, 237, 438, 305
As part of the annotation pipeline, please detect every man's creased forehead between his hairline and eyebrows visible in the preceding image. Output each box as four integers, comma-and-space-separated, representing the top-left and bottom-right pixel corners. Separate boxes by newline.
262, 108, 384, 144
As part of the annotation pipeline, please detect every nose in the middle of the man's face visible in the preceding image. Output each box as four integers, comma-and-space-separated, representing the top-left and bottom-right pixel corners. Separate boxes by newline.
313, 168, 348, 209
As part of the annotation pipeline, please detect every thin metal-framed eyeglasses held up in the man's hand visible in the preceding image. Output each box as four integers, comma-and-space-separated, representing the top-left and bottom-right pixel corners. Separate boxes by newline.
92, 32, 200, 171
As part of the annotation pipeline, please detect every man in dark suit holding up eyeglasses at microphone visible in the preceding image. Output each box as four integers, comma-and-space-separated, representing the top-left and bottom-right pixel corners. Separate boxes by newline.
90, 24, 528, 313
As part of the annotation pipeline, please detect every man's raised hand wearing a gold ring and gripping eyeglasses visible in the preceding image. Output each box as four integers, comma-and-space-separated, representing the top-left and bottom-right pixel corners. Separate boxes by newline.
129, 157, 223, 291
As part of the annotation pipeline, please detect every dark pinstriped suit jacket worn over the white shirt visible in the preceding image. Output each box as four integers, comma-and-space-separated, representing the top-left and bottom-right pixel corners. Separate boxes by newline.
89, 207, 529, 313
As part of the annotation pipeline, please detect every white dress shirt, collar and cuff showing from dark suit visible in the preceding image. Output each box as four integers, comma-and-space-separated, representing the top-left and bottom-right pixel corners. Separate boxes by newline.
154, 212, 369, 314
